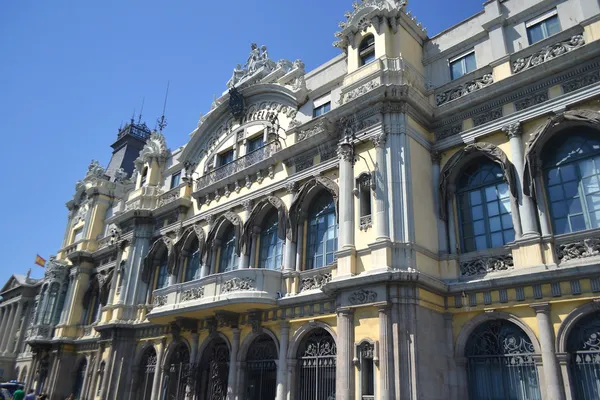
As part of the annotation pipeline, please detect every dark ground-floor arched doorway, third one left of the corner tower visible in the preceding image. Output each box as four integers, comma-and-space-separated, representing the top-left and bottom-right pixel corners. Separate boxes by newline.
196, 338, 229, 400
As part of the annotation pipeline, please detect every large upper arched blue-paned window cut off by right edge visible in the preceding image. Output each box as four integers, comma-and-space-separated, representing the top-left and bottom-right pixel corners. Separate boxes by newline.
542, 132, 600, 234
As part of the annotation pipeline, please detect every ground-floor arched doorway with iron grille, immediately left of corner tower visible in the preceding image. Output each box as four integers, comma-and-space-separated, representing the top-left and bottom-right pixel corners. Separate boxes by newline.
296, 328, 337, 400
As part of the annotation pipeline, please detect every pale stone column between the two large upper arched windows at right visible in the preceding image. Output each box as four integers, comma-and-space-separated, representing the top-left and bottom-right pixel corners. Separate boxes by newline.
502, 122, 540, 238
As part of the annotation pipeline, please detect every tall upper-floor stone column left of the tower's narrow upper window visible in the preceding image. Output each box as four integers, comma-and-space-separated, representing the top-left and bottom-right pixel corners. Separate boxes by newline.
338, 138, 354, 249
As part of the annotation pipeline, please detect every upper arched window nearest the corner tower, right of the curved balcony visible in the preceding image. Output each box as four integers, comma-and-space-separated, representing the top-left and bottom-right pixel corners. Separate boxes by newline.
306, 193, 337, 269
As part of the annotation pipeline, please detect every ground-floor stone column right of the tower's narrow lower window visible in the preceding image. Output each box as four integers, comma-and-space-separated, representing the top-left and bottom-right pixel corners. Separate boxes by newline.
379, 305, 395, 400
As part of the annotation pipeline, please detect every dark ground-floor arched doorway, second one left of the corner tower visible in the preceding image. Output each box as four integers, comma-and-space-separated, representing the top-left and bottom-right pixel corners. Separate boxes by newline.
245, 334, 277, 400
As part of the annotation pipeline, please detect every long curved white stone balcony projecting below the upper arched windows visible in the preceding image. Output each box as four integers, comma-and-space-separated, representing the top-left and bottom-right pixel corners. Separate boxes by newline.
148, 269, 283, 323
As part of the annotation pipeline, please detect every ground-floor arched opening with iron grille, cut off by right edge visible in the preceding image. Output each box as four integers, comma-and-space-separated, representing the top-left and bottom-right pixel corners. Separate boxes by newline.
567, 311, 600, 400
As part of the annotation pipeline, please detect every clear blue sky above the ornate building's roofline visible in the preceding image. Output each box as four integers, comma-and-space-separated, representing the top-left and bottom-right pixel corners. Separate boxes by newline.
0, 0, 483, 285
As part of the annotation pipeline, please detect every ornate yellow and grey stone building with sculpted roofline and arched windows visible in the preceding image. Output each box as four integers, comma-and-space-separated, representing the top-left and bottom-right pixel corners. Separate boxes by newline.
0, 0, 600, 400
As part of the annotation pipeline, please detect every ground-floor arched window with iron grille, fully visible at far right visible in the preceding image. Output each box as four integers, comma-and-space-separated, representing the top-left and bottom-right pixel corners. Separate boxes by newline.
465, 319, 541, 400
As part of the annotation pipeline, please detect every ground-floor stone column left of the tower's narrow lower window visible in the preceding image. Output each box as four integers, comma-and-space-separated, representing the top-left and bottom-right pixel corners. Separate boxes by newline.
335, 309, 354, 400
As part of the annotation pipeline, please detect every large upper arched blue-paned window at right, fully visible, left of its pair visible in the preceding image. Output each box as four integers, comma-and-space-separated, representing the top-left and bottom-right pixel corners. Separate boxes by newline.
456, 161, 515, 253
